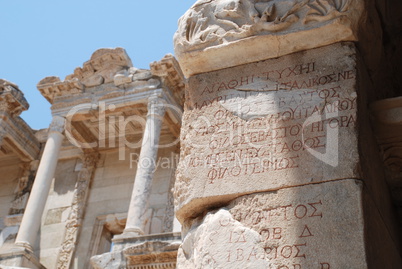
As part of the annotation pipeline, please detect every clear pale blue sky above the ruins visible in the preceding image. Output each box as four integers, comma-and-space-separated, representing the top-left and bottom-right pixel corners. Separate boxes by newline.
0, 0, 195, 129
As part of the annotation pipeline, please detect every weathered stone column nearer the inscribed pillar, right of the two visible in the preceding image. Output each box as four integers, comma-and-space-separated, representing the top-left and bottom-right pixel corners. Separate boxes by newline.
124, 96, 165, 235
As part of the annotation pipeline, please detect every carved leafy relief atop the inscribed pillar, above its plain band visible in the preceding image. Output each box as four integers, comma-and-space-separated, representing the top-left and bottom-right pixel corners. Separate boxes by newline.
175, 0, 351, 50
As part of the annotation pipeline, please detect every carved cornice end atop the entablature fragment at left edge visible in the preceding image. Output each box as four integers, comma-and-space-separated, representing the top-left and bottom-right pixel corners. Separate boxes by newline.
0, 79, 29, 117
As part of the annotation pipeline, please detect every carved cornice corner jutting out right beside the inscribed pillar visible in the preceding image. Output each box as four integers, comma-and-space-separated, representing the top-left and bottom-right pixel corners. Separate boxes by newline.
150, 54, 185, 105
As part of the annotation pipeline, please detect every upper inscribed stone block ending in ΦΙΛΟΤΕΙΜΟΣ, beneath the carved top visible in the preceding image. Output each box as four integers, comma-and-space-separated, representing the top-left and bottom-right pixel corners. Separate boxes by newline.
175, 43, 360, 221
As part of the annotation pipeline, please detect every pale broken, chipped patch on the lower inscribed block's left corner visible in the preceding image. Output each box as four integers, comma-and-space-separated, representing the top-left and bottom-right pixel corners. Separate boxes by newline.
177, 209, 271, 269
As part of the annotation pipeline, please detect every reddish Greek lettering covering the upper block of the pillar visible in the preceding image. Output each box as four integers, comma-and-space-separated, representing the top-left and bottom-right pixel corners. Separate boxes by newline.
182, 46, 357, 188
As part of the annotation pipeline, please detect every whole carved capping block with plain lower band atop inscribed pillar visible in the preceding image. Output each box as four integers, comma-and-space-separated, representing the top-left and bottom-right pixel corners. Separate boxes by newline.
174, 0, 365, 76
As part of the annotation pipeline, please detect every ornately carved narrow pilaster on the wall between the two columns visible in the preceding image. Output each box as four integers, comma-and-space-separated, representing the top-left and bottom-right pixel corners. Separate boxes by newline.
57, 152, 99, 269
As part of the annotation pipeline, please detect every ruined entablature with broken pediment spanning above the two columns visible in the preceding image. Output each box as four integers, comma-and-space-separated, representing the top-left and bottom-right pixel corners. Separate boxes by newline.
37, 48, 184, 148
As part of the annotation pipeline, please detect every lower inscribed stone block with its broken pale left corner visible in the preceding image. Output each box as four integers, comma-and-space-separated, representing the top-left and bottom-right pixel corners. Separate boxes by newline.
178, 179, 367, 269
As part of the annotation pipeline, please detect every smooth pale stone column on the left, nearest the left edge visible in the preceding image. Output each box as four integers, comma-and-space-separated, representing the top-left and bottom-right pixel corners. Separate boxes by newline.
15, 116, 65, 250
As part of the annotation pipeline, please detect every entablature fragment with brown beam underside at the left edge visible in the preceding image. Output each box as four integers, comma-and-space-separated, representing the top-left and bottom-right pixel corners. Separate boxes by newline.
0, 79, 40, 163
